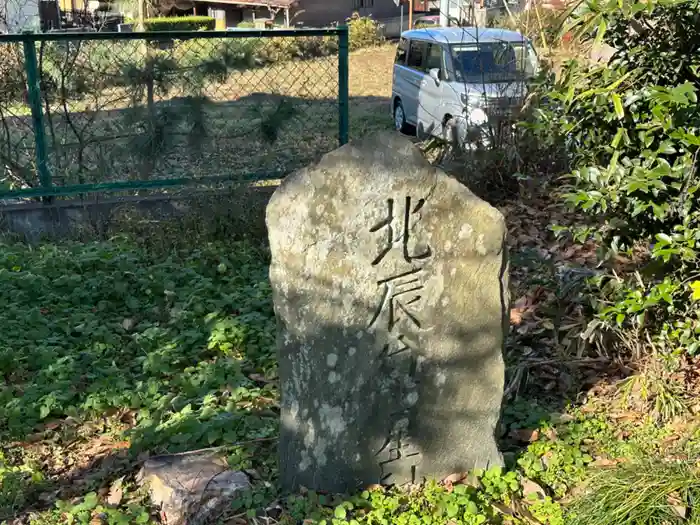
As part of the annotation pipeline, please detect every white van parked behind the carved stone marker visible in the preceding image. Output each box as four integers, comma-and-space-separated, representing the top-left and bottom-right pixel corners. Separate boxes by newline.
392, 27, 538, 147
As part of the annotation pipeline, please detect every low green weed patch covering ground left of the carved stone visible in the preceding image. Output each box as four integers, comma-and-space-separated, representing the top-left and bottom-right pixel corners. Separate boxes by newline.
0, 241, 278, 523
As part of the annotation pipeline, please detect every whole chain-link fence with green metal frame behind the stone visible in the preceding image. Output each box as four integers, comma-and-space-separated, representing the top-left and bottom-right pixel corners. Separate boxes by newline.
0, 27, 348, 198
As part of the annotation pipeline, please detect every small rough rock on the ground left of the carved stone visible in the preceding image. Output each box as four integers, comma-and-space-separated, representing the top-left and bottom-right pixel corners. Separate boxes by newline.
138, 453, 250, 525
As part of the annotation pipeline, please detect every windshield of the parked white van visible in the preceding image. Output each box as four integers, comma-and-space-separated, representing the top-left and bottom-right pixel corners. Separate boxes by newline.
450, 42, 537, 83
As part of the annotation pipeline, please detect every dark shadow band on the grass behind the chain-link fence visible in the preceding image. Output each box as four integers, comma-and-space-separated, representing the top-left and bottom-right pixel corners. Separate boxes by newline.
0, 93, 392, 192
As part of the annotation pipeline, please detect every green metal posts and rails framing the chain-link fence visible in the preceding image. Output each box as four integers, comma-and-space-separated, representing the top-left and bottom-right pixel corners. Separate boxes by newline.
0, 26, 349, 199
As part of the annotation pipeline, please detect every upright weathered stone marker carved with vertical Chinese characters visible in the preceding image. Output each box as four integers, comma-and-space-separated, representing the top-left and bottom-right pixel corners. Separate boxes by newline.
267, 133, 507, 491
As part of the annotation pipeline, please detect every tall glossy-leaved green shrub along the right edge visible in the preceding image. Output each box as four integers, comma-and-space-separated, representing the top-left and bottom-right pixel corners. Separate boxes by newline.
540, 0, 700, 362
